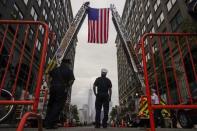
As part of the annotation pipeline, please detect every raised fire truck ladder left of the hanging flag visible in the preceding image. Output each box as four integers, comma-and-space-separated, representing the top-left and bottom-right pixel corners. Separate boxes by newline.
45, 2, 89, 73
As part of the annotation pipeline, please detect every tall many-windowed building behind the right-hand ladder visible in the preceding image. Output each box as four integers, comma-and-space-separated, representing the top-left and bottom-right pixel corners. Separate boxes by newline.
117, 0, 195, 105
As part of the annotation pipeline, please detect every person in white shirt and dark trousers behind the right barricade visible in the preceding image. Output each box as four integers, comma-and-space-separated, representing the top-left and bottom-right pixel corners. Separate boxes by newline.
151, 88, 164, 127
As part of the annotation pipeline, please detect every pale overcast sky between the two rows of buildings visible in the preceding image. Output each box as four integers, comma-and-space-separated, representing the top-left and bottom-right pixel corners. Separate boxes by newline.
70, 0, 125, 108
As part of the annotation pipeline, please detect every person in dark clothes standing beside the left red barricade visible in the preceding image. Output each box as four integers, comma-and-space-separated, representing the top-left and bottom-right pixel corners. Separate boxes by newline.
44, 59, 75, 129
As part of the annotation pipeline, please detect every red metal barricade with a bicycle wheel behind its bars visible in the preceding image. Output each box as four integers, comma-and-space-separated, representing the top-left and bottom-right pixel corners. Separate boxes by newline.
0, 20, 49, 131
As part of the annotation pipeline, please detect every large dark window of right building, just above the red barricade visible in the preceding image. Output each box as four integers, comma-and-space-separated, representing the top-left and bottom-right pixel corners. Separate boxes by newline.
170, 11, 183, 32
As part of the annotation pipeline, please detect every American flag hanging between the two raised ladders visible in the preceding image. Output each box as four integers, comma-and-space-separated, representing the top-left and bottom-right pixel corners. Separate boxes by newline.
88, 8, 109, 43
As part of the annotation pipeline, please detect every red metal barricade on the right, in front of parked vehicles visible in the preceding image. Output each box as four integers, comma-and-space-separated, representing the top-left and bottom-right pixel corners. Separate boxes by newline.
141, 33, 197, 131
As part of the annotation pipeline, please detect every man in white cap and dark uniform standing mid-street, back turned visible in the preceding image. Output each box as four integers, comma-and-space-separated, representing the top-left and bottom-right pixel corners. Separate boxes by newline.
93, 69, 112, 128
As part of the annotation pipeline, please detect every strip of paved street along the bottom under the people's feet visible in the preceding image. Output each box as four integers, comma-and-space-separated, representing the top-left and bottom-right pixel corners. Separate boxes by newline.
0, 127, 196, 131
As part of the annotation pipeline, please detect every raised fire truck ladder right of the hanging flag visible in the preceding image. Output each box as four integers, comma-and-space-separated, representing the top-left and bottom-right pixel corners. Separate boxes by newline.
110, 5, 145, 94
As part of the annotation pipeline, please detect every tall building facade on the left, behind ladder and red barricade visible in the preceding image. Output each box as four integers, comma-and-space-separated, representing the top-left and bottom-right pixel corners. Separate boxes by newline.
0, 0, 76, 121
